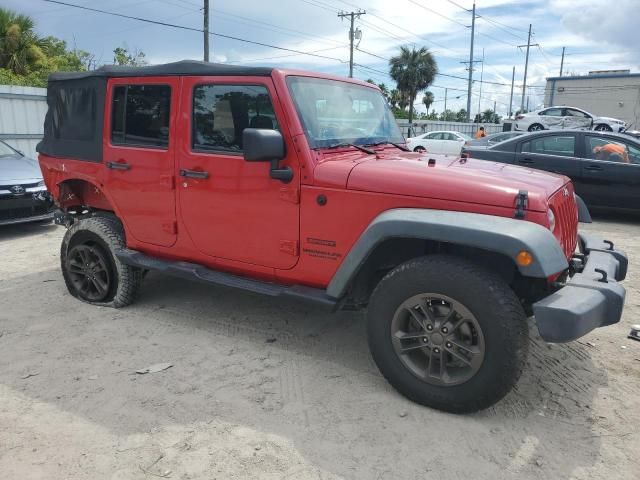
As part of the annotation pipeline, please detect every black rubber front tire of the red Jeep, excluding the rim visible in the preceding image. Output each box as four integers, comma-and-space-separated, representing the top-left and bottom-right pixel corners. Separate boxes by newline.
367, 255, 528, 413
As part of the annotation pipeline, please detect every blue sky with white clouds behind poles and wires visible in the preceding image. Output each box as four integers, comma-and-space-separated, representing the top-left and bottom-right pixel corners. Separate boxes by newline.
2, 0, 640, 115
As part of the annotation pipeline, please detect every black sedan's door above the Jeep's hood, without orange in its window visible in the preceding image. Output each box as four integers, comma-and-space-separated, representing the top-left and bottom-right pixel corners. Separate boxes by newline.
515, 133, 581, 179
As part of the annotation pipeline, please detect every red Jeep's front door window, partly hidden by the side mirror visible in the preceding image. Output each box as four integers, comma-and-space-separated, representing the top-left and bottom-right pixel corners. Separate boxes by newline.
191, 85, 279, 153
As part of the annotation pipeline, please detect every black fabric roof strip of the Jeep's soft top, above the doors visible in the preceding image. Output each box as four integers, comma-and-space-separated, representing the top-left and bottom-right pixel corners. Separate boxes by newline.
49, 60, 273, 82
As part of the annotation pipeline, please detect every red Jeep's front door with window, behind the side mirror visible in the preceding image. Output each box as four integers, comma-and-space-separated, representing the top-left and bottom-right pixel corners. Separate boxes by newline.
178, 77, 300, 269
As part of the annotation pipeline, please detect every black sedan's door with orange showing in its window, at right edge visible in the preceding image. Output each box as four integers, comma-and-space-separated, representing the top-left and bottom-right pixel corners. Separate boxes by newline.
576, 135, 640, 209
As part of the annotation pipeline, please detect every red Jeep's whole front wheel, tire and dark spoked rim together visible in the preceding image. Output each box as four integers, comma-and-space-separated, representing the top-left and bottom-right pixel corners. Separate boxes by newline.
367, 255, 528, 413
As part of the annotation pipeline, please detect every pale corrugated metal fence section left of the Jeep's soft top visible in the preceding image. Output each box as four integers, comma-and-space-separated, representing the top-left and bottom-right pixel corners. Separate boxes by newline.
0, 85, 47, 158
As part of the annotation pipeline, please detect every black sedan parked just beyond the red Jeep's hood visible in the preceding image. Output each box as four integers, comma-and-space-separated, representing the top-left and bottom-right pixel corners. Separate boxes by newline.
462, 130, 640, 210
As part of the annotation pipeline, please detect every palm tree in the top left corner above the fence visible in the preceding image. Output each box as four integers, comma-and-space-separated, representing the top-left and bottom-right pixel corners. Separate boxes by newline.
0, 8, 45, 75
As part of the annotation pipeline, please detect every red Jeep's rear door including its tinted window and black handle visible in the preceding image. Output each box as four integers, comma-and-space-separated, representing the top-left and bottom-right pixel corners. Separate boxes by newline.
103, 77, 180, 247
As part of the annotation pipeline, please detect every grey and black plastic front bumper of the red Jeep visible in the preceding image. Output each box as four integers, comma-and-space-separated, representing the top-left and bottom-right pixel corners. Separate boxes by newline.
533, 234, 629, 343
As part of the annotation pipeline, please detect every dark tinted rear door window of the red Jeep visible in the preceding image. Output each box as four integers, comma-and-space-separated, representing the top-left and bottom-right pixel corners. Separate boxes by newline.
111, 85, 171, 148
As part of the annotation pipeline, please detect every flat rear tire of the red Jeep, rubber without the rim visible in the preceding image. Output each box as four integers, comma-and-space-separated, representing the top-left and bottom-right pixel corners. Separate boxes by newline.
60, 216, 143, 308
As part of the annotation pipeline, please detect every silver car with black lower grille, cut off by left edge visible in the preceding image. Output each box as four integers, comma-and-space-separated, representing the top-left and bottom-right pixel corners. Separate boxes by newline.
0, 141, 53, 225
